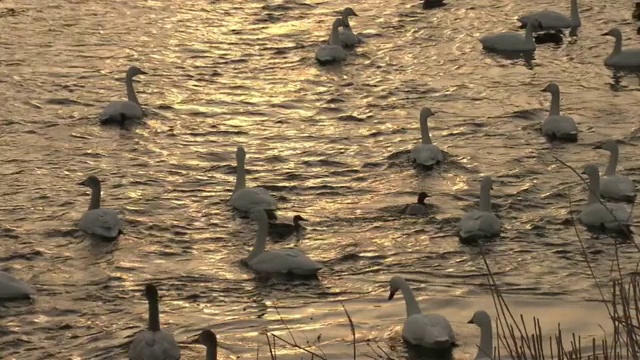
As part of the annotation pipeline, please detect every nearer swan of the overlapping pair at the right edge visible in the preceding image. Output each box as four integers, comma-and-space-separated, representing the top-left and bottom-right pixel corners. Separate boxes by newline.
579, 165, 631, 234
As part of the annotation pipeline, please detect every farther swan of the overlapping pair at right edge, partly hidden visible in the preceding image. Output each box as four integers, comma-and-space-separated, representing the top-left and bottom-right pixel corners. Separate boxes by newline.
594, 140, 636, 202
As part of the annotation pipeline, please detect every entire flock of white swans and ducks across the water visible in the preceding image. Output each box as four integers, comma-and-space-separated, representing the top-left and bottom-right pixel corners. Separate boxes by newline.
0, 0, 640, 360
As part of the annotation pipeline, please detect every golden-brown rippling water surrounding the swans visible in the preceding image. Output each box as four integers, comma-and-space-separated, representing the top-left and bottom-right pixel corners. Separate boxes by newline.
0, 0, 640, 360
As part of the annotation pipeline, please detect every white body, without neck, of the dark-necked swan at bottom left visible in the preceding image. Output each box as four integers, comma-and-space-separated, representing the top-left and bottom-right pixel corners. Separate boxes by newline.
129, 330, 180, 360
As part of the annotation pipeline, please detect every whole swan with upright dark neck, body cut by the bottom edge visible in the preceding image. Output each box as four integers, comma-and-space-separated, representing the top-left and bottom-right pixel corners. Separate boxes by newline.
129, 284, 180, 360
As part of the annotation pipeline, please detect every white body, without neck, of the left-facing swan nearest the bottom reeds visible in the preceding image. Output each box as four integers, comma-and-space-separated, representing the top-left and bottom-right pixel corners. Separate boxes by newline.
402, 314, 456, 348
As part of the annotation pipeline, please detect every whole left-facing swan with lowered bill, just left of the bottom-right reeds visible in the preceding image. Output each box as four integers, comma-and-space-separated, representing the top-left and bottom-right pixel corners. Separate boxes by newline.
389, 276, 456, 349
